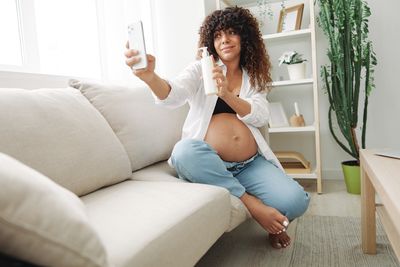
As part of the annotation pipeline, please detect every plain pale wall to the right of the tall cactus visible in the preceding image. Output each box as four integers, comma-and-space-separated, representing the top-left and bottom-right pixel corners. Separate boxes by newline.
368, 0, 400, 149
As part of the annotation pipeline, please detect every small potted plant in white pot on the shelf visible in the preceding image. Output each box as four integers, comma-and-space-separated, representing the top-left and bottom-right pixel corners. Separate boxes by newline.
279, 51, 307, 80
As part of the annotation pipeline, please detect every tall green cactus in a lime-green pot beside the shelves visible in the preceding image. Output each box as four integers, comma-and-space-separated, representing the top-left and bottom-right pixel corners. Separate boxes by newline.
318, 0, 377, 193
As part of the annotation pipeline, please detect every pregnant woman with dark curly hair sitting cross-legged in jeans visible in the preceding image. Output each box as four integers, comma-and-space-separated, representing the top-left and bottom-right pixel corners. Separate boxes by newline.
125, 7, 309, 248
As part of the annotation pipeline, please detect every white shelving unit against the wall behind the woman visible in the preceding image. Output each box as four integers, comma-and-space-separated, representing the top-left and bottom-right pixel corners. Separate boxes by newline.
212, 0, 322, 194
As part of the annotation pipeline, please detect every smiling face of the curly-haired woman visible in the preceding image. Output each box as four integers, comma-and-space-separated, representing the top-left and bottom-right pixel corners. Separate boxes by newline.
214, 29, 240, 61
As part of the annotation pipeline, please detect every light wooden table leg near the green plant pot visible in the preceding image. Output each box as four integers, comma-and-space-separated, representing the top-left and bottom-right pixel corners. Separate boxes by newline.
361, 166, 376, 254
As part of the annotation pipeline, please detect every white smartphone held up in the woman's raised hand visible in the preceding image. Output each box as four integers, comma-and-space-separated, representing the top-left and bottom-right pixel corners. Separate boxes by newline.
128, 21, 147, 69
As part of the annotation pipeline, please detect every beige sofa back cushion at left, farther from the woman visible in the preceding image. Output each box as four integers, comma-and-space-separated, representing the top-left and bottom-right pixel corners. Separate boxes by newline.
0, 88, 131, 195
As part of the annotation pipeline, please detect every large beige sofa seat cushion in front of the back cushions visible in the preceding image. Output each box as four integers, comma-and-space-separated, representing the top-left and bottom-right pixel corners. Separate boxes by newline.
82, 181, 230, 267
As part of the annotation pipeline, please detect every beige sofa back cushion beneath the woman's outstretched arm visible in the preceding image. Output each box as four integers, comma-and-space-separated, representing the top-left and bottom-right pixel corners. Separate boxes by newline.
70, 80, 188, 170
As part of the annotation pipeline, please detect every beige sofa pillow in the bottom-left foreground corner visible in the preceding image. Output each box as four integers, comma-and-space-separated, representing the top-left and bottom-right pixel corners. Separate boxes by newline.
0, 153, 109, 267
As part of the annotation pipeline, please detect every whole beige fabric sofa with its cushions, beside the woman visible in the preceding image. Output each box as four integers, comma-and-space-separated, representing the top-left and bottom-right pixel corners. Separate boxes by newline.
0, 80, 253, 267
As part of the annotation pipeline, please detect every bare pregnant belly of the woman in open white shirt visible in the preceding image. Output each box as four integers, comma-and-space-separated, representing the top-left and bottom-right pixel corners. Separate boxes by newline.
205, 113, 257, 161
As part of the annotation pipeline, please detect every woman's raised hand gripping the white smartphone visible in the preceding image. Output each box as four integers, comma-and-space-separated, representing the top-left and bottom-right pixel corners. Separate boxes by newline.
125, 42, 156, 83
